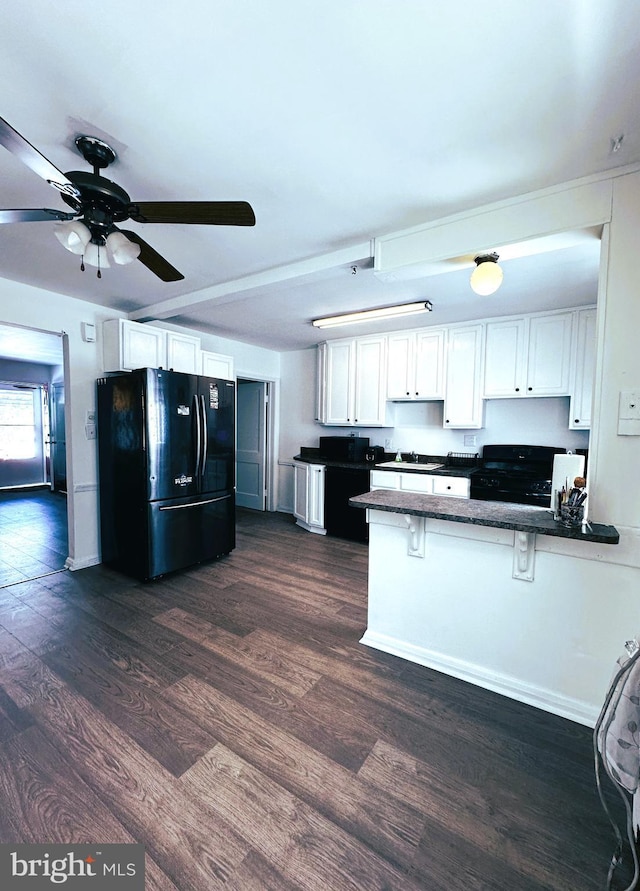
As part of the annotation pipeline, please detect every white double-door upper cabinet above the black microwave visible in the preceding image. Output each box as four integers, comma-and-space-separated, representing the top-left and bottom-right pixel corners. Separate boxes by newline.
318, 337, 386, 427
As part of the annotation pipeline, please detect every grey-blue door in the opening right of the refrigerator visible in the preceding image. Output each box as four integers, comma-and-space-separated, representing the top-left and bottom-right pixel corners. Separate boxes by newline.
236, 380, 267, 510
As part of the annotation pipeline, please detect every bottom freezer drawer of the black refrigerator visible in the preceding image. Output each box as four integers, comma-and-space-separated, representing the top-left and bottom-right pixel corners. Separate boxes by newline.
145, 493, 235, 579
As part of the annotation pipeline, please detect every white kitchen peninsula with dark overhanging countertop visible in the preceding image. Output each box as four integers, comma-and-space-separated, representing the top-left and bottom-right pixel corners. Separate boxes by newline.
350, 490, 619, 725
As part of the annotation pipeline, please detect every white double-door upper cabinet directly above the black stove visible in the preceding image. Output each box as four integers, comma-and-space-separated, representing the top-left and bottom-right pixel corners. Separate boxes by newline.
483, 312, 573, 399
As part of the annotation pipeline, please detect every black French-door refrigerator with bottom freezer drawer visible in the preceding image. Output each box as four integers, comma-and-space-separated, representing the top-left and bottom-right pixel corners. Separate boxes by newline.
97, 368, 235, 581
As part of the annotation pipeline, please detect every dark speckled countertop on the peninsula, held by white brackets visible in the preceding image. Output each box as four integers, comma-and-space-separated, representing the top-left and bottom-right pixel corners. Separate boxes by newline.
349, 489, 620, 544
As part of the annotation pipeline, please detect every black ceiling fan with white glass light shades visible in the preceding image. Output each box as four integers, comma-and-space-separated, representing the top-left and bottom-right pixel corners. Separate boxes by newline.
0, 118, 256, 282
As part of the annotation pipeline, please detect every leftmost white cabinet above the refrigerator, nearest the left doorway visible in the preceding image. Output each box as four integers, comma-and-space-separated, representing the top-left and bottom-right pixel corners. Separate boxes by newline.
102, 319, 167, 371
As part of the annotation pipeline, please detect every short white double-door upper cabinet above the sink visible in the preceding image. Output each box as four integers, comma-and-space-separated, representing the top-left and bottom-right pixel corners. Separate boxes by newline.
387, 328, 445, 401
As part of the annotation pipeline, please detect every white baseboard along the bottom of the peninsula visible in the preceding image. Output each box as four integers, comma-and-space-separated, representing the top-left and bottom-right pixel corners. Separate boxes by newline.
360, 630, 600, 727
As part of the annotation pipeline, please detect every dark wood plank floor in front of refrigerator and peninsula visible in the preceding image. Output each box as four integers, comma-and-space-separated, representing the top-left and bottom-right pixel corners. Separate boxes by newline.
0, 511, 628, 891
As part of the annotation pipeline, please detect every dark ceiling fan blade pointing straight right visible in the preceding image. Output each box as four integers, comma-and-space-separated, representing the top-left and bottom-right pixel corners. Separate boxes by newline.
129, 201, 256, 226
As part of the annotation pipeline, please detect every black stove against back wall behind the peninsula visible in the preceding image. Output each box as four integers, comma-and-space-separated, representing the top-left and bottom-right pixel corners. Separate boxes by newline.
470, 445, 567, 507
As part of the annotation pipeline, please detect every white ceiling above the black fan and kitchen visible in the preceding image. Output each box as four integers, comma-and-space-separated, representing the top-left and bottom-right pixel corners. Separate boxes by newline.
0, 0, 640, 350
